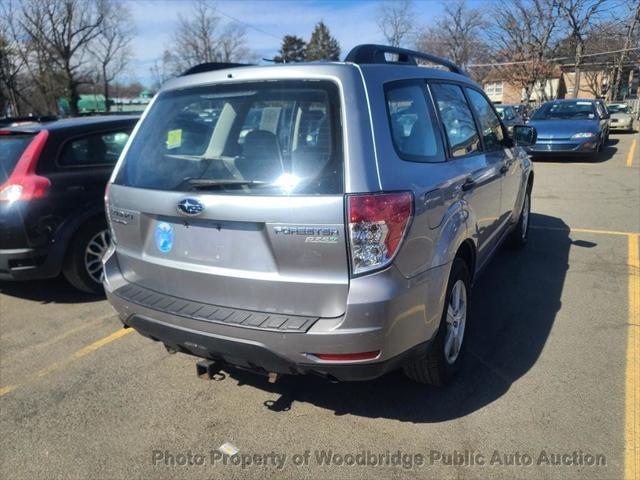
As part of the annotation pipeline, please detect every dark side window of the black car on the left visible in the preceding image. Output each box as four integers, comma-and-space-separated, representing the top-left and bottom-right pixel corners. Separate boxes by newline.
58, 131, 129, 167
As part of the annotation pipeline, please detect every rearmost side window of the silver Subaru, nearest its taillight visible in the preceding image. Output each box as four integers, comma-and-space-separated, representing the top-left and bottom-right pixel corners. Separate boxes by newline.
385, 80, 444, 162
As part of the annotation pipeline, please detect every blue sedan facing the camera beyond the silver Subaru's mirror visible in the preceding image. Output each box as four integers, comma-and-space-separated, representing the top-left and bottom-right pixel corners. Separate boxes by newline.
527, 99, 609, 158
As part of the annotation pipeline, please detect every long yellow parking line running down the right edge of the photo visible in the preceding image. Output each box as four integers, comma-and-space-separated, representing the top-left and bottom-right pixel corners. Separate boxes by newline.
624, 235, 640, 480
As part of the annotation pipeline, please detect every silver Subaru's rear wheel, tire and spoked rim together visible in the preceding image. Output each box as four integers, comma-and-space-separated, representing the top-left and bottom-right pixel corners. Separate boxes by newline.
403, 258, 471, 386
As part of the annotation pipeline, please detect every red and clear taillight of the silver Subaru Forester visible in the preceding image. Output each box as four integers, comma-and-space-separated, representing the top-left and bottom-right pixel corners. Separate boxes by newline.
347, 192, 413, 275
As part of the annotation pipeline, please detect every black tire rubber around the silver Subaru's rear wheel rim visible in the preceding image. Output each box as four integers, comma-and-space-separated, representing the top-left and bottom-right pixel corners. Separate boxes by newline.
403, 258, 471, 387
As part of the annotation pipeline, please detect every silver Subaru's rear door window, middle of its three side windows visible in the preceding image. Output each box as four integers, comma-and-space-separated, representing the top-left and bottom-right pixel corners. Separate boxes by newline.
431, 83, 480, 157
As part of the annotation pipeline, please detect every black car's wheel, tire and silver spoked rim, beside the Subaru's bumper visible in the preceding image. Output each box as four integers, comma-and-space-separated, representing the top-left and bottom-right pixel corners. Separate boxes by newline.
62, 219, 111, 294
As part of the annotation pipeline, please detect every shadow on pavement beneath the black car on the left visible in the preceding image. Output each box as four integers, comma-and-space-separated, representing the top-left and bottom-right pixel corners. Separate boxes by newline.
0, 276, 105, 304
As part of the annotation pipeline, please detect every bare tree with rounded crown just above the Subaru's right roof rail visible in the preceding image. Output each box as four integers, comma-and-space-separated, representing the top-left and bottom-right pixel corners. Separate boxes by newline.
416, 0, 487, 68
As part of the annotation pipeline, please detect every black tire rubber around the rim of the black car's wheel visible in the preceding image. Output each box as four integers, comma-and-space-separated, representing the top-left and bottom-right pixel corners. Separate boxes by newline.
62, 218, 108, 295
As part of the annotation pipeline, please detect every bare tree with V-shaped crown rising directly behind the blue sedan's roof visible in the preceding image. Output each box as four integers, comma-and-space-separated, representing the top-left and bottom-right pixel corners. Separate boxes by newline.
557, 0, 612, 98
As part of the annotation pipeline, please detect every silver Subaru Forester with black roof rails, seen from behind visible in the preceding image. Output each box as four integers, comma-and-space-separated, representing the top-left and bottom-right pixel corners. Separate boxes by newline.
103, 45, 535, 385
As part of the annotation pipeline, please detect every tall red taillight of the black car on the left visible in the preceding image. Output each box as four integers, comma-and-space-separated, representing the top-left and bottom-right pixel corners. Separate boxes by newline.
0, 130, 51, 203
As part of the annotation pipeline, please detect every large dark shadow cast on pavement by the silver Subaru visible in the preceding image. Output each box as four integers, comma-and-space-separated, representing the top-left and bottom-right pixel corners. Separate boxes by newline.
221, 214, 576, 423
